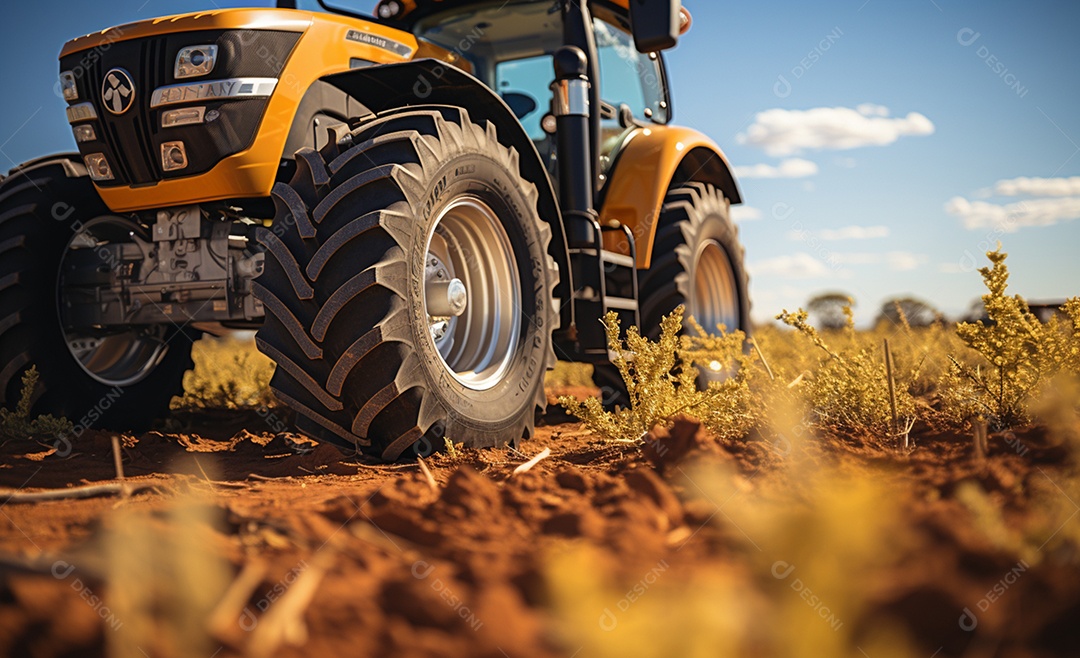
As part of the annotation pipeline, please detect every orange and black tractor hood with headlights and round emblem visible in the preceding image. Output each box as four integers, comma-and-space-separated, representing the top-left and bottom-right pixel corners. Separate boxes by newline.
59, 9, 423, 212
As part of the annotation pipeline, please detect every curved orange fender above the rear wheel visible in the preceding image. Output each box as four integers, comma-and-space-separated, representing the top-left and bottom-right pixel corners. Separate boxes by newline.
599, 125, 742, 269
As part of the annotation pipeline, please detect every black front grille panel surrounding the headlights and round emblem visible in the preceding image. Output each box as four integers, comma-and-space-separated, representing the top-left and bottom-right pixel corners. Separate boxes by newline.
60, 30, 300, 187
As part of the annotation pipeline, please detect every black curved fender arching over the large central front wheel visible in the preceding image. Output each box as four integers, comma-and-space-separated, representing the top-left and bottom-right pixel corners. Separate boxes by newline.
322, 59, 573, 315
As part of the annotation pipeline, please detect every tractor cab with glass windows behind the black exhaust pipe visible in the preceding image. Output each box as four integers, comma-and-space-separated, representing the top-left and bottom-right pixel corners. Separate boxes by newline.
295, 0, 690, 193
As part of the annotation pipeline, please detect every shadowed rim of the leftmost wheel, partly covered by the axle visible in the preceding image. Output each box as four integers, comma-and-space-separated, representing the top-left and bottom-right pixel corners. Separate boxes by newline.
56, 217, 168, 387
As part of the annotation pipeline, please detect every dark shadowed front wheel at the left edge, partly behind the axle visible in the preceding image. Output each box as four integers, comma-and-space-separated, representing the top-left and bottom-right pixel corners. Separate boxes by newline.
0, 156, 199, 430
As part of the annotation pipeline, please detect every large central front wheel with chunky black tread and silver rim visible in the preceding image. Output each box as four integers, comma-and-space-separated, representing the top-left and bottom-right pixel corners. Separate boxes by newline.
255, 108, 558, 460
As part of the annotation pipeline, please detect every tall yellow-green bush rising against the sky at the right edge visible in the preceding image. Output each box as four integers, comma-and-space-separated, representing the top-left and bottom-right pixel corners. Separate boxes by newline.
942, 245, 1080, 430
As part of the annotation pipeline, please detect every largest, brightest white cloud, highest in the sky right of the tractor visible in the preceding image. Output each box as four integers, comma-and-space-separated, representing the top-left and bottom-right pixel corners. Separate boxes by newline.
737, 104, 934, 157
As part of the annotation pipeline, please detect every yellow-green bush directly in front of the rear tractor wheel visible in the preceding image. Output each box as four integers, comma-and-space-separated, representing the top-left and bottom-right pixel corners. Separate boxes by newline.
558, 306, 752, 443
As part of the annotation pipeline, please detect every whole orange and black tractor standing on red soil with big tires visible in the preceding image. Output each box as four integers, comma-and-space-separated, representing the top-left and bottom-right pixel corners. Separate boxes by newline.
0, 0, 748, 460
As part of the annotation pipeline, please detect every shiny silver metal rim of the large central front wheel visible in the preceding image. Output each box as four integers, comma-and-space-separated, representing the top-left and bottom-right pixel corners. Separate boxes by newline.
423, 196, 522, 390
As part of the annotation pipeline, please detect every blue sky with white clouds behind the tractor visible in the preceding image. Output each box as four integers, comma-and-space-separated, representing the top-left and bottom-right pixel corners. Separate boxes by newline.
0, 0, 1080, 321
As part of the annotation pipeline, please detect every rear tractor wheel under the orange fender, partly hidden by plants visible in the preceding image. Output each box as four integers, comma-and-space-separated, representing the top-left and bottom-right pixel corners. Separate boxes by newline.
593, 183, 751, 406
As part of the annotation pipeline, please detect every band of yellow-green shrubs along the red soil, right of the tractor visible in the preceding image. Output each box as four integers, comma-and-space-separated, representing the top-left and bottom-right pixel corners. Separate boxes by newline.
561, 246, 1080, 445
